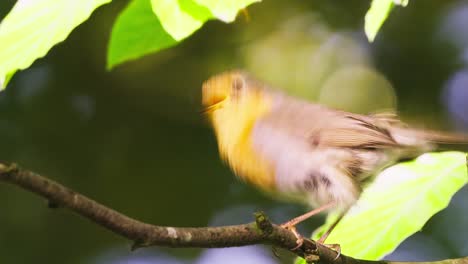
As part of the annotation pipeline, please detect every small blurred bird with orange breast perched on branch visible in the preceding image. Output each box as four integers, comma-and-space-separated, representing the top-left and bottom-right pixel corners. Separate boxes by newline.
201, 70, 468, 249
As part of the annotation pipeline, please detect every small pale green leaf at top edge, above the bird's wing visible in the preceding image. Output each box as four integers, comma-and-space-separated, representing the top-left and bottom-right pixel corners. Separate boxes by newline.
364, 0, 409, 42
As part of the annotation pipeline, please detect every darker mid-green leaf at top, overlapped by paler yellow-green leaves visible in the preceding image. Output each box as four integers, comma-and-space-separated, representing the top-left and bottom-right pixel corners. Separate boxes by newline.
107, 0, 177, 70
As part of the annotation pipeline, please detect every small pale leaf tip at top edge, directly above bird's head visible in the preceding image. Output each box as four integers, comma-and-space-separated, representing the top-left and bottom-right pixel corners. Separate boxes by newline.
195, 0, 261, 23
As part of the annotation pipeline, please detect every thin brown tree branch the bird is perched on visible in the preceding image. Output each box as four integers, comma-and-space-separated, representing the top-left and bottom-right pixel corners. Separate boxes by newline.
0, 163, 468, 264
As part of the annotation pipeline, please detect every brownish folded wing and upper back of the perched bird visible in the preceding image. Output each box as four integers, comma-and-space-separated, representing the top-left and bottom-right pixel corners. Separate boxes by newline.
264, 97, 401, 149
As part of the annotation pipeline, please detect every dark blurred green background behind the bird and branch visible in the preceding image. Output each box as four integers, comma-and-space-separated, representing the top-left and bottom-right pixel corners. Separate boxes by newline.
0, 0, 468, 264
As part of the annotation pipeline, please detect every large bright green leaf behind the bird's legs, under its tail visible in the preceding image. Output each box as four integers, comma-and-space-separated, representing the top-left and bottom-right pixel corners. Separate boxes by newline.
300, 152, 468, 260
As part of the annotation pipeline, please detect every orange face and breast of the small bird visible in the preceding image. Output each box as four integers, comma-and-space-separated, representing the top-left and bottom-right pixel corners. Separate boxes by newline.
202, 71, 275, 191
